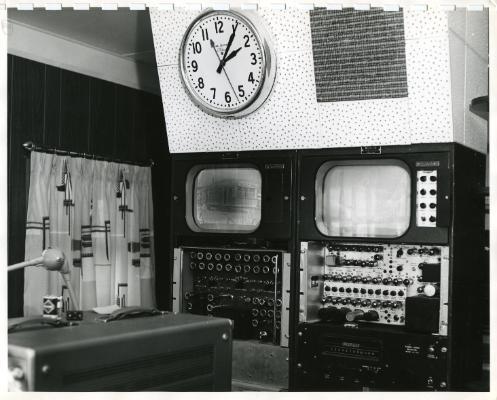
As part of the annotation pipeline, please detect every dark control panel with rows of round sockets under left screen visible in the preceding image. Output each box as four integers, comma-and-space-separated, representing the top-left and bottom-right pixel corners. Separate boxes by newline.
173, 247, 290, 346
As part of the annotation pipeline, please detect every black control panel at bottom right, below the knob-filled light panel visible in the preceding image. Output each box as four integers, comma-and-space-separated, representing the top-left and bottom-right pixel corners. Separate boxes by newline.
296, 323, 450, 391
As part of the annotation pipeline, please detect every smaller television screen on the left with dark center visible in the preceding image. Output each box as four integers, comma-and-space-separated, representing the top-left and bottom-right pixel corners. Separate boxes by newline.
193, 167, 262, 233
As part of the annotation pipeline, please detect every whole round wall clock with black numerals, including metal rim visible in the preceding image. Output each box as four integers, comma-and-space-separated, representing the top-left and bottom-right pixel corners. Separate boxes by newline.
180, 9, 276, 118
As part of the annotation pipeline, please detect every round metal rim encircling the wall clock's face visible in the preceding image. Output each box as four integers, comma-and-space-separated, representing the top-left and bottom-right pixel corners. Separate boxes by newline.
179, 9, 276, 118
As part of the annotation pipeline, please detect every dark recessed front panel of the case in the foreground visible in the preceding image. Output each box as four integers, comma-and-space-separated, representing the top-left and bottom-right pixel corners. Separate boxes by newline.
62, 346, 214, 392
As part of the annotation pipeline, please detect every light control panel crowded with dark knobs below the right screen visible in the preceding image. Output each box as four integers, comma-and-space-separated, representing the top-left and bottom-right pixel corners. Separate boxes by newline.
300, 242, 448, 334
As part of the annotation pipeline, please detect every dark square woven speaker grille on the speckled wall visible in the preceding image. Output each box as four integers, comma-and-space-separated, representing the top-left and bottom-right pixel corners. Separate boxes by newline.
310, 8, 407, 102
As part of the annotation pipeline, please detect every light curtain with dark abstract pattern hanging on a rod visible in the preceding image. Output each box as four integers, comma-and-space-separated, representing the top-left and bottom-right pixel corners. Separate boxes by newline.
24, 152, 155, 316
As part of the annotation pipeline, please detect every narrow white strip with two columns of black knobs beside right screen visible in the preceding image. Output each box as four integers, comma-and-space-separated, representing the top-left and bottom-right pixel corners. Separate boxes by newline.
416, 170, 437, 227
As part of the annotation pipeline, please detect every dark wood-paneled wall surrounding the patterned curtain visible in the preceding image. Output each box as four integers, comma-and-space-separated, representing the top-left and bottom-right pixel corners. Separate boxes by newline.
7, 55, 171, 317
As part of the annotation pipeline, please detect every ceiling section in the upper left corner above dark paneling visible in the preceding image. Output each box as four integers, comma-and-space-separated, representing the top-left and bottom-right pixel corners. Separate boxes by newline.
8, 9, 155, 66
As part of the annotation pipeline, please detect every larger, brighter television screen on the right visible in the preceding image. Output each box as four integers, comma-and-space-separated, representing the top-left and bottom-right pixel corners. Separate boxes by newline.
316, 160, 411, 238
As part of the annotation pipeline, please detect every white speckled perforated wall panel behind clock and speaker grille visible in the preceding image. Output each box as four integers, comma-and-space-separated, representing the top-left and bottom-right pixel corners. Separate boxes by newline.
150, 8, 483, 153
